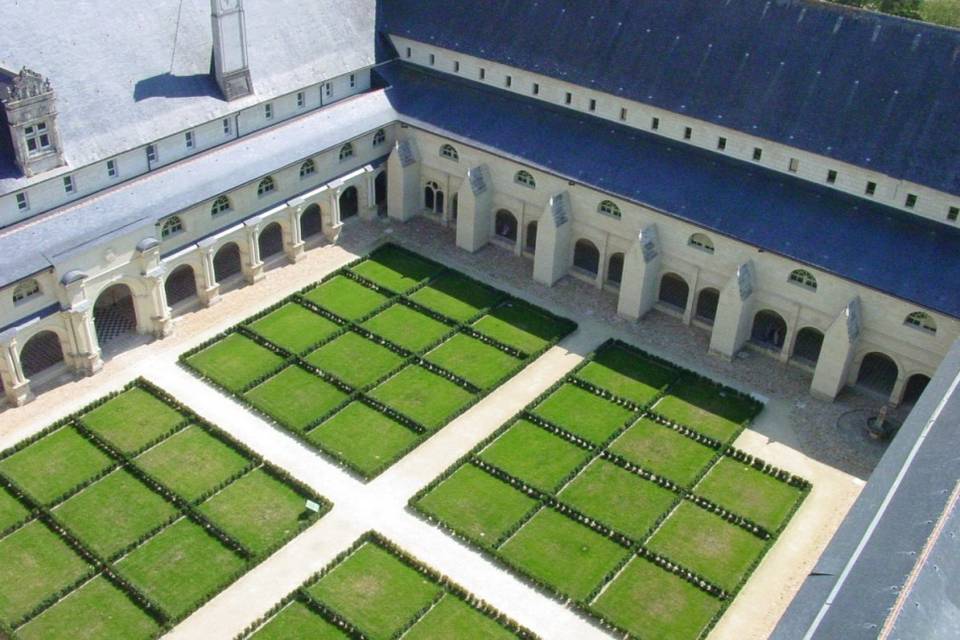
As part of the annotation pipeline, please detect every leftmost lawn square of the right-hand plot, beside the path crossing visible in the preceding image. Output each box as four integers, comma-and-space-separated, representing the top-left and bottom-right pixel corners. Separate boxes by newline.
417, 464, 537, 548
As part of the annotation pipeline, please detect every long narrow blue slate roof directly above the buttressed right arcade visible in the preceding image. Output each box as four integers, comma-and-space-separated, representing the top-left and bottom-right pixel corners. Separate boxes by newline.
380, 63, 960, 317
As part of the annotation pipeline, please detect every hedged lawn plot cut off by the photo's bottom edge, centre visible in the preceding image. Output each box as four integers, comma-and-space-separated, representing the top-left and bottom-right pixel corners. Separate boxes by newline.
238, 532, 537, 640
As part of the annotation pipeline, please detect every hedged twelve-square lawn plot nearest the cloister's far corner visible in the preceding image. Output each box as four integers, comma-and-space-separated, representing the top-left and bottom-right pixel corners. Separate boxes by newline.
181, 244, 576, 479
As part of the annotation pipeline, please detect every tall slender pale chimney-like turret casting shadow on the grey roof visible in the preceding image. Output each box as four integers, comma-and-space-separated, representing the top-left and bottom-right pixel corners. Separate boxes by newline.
210, 0, 253, 100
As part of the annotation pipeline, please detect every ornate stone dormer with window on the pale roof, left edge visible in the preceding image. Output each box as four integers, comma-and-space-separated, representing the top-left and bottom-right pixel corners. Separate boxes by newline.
0, 67, 65, 176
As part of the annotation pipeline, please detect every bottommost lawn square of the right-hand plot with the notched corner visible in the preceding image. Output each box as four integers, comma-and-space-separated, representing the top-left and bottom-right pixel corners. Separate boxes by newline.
591, 558, 723, 640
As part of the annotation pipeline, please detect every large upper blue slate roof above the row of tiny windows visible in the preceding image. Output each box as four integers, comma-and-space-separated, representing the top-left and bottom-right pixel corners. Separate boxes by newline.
378, 0, 960, 195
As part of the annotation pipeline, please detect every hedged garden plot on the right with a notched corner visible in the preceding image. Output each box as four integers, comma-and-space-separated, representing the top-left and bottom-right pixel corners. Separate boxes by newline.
410, 341, 810, 640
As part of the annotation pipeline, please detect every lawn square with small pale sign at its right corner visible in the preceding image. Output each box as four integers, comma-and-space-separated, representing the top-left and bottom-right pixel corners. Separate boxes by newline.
199, 469, 306, 555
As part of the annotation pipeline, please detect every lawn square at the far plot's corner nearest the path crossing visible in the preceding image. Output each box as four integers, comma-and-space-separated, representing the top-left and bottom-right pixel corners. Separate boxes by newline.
307, 401, 420, 478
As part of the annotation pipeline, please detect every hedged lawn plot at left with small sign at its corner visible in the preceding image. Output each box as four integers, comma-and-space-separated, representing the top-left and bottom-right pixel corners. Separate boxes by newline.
0, 379, 330, 640
